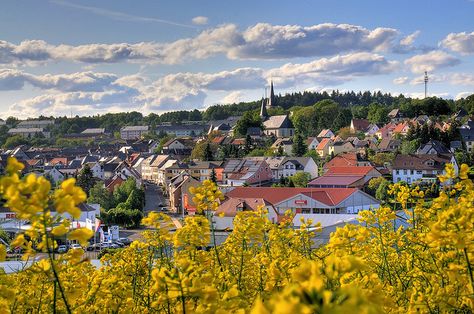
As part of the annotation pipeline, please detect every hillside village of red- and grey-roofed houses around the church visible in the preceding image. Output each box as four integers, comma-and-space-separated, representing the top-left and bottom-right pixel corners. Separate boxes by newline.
0, 84, 474, 238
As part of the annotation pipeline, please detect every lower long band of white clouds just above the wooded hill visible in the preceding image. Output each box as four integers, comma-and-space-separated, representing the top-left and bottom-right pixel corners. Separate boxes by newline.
7, 53, 398, 116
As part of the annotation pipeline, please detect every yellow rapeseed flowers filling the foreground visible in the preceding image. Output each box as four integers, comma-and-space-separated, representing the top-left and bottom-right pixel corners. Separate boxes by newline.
0, 159, 474, 313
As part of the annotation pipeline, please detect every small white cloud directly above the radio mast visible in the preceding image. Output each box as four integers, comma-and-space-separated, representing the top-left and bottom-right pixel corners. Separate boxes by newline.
405, 50, 461, 73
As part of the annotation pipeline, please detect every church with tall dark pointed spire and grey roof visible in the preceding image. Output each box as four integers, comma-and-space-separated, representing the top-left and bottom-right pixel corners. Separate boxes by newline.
260, 82, 295, 137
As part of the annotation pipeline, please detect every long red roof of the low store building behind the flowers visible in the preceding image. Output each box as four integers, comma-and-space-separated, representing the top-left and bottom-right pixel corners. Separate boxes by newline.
226, 187, 357, 206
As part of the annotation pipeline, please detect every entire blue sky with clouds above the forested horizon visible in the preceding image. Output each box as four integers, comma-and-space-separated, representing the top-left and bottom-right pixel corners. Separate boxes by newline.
0, 0, 474, 118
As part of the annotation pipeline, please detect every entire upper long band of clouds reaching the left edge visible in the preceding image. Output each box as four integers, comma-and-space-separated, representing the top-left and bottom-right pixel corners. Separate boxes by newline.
0, 22, 417, 64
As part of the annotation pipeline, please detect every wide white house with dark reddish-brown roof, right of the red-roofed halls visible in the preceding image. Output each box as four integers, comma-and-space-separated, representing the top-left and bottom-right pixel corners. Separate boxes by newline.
392, 154, 458, 184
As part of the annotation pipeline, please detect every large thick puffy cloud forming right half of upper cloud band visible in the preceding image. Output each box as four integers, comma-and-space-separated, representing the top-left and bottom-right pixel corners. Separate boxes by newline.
228, 23, 398, 59
